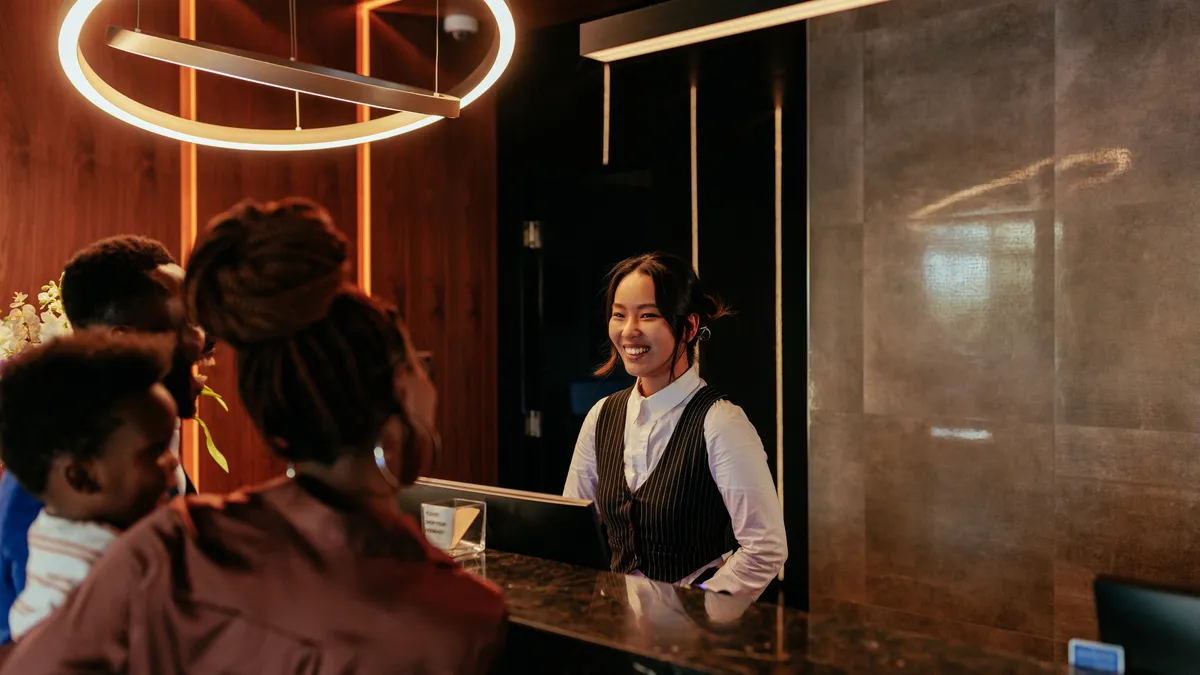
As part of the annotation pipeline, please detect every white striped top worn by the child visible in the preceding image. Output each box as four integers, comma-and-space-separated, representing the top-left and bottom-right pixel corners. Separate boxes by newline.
8, 510, 119, 640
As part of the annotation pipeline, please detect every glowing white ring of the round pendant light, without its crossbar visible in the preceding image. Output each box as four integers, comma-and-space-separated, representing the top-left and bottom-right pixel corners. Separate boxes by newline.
58, 0, 516, 151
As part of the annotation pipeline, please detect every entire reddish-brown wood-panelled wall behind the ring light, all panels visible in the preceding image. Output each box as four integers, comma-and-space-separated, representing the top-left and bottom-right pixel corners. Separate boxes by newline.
0, 0, 496, 492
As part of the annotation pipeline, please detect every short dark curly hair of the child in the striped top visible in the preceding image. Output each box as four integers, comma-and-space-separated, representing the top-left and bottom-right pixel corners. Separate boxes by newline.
0, 330, 169, 495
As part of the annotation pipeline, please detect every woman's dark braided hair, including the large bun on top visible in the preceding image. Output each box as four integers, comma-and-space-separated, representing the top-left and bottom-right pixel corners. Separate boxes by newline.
185, 198, 410, 464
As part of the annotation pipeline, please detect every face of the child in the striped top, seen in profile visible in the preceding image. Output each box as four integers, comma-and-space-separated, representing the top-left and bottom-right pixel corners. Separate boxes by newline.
48, 384, 179, 530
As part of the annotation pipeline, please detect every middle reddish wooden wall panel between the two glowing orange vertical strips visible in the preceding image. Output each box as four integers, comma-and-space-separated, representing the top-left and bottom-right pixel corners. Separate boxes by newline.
196, 0, 358, 492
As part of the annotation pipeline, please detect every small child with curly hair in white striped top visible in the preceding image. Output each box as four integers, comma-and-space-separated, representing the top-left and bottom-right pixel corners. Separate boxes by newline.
0, 330, 178, 640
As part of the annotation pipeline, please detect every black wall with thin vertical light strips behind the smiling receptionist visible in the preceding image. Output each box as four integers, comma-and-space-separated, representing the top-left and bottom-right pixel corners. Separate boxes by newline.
498, 18, 808, 604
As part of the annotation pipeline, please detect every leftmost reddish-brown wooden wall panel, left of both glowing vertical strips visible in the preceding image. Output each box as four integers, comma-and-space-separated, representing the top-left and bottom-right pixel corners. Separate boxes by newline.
0, 0, 179, 304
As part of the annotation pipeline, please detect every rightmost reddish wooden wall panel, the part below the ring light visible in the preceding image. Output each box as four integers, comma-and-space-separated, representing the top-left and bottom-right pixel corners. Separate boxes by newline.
371, 96, 497, 484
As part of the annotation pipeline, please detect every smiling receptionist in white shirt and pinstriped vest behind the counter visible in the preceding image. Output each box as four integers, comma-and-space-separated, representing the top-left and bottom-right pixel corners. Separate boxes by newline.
563, 253, 787, 598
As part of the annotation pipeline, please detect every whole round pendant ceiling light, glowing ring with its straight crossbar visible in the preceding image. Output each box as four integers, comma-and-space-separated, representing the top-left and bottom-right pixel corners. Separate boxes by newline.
58, 0, 516, 151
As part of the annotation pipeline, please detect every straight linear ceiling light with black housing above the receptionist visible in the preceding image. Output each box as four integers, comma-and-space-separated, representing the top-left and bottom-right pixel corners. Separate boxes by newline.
580, 0, 888, 62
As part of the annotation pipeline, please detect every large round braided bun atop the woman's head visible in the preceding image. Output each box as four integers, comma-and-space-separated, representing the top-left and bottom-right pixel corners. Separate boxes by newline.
186, 198, 347, 347
